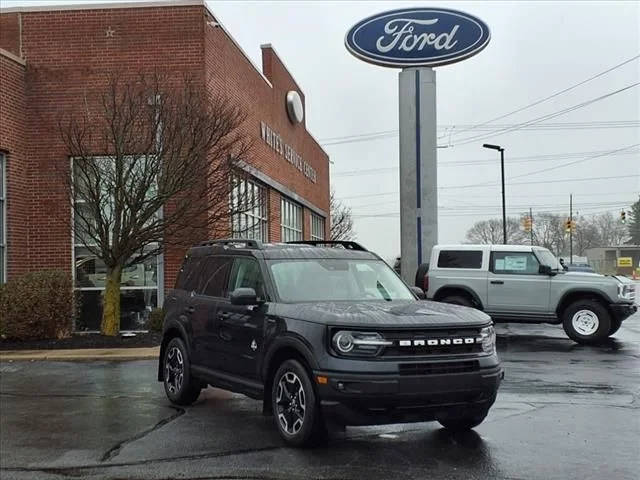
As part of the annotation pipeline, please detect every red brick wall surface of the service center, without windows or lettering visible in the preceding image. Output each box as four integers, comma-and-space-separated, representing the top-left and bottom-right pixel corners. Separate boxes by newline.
0, 1, 329, 294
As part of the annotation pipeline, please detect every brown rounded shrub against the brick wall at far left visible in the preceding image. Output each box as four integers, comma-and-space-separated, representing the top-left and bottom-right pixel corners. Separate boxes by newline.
0, 270, 76, 340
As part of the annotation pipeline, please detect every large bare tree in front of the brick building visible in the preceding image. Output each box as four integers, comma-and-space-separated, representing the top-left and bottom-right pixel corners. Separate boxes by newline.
59, 74, 251, 335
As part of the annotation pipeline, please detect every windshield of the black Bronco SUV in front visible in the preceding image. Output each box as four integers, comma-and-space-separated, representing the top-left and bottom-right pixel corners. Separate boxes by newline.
268, 258, 415, 302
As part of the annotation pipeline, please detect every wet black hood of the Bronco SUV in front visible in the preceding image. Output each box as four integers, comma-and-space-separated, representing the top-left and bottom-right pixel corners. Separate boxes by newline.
274, 300, 491, 328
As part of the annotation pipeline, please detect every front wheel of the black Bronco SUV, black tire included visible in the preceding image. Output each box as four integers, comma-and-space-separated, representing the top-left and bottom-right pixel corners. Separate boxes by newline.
271, 360, 326, 447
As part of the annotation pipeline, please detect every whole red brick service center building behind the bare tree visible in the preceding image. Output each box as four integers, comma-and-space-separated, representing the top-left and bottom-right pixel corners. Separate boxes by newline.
0, 0, 329, 330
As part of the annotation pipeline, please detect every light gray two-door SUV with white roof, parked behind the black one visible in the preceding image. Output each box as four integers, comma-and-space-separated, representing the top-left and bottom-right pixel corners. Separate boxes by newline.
416, 245, 637, 344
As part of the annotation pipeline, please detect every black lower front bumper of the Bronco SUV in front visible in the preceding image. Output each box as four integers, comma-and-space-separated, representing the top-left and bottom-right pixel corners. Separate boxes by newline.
314, 365, 504, 425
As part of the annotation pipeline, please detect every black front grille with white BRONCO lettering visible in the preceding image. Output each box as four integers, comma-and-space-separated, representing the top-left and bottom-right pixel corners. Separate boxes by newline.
381, 328, 482, 357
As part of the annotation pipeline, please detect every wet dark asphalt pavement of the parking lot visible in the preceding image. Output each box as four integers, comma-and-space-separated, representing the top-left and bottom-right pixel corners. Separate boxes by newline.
0, 314, 640, 480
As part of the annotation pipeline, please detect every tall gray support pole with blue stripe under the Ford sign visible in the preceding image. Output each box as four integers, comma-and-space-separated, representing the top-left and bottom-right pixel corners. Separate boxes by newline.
399, 67, 438, 285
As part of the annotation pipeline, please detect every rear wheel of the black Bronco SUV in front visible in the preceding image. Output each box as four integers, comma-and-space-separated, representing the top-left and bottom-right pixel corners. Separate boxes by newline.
162, 337, 202, 405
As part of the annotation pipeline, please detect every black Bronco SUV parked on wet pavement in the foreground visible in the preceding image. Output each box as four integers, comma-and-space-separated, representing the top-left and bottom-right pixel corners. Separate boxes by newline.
158, 239, 503, 445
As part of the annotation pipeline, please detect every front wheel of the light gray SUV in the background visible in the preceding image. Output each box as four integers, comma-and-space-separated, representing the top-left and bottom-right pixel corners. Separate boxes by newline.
562, 298, 612, 345
